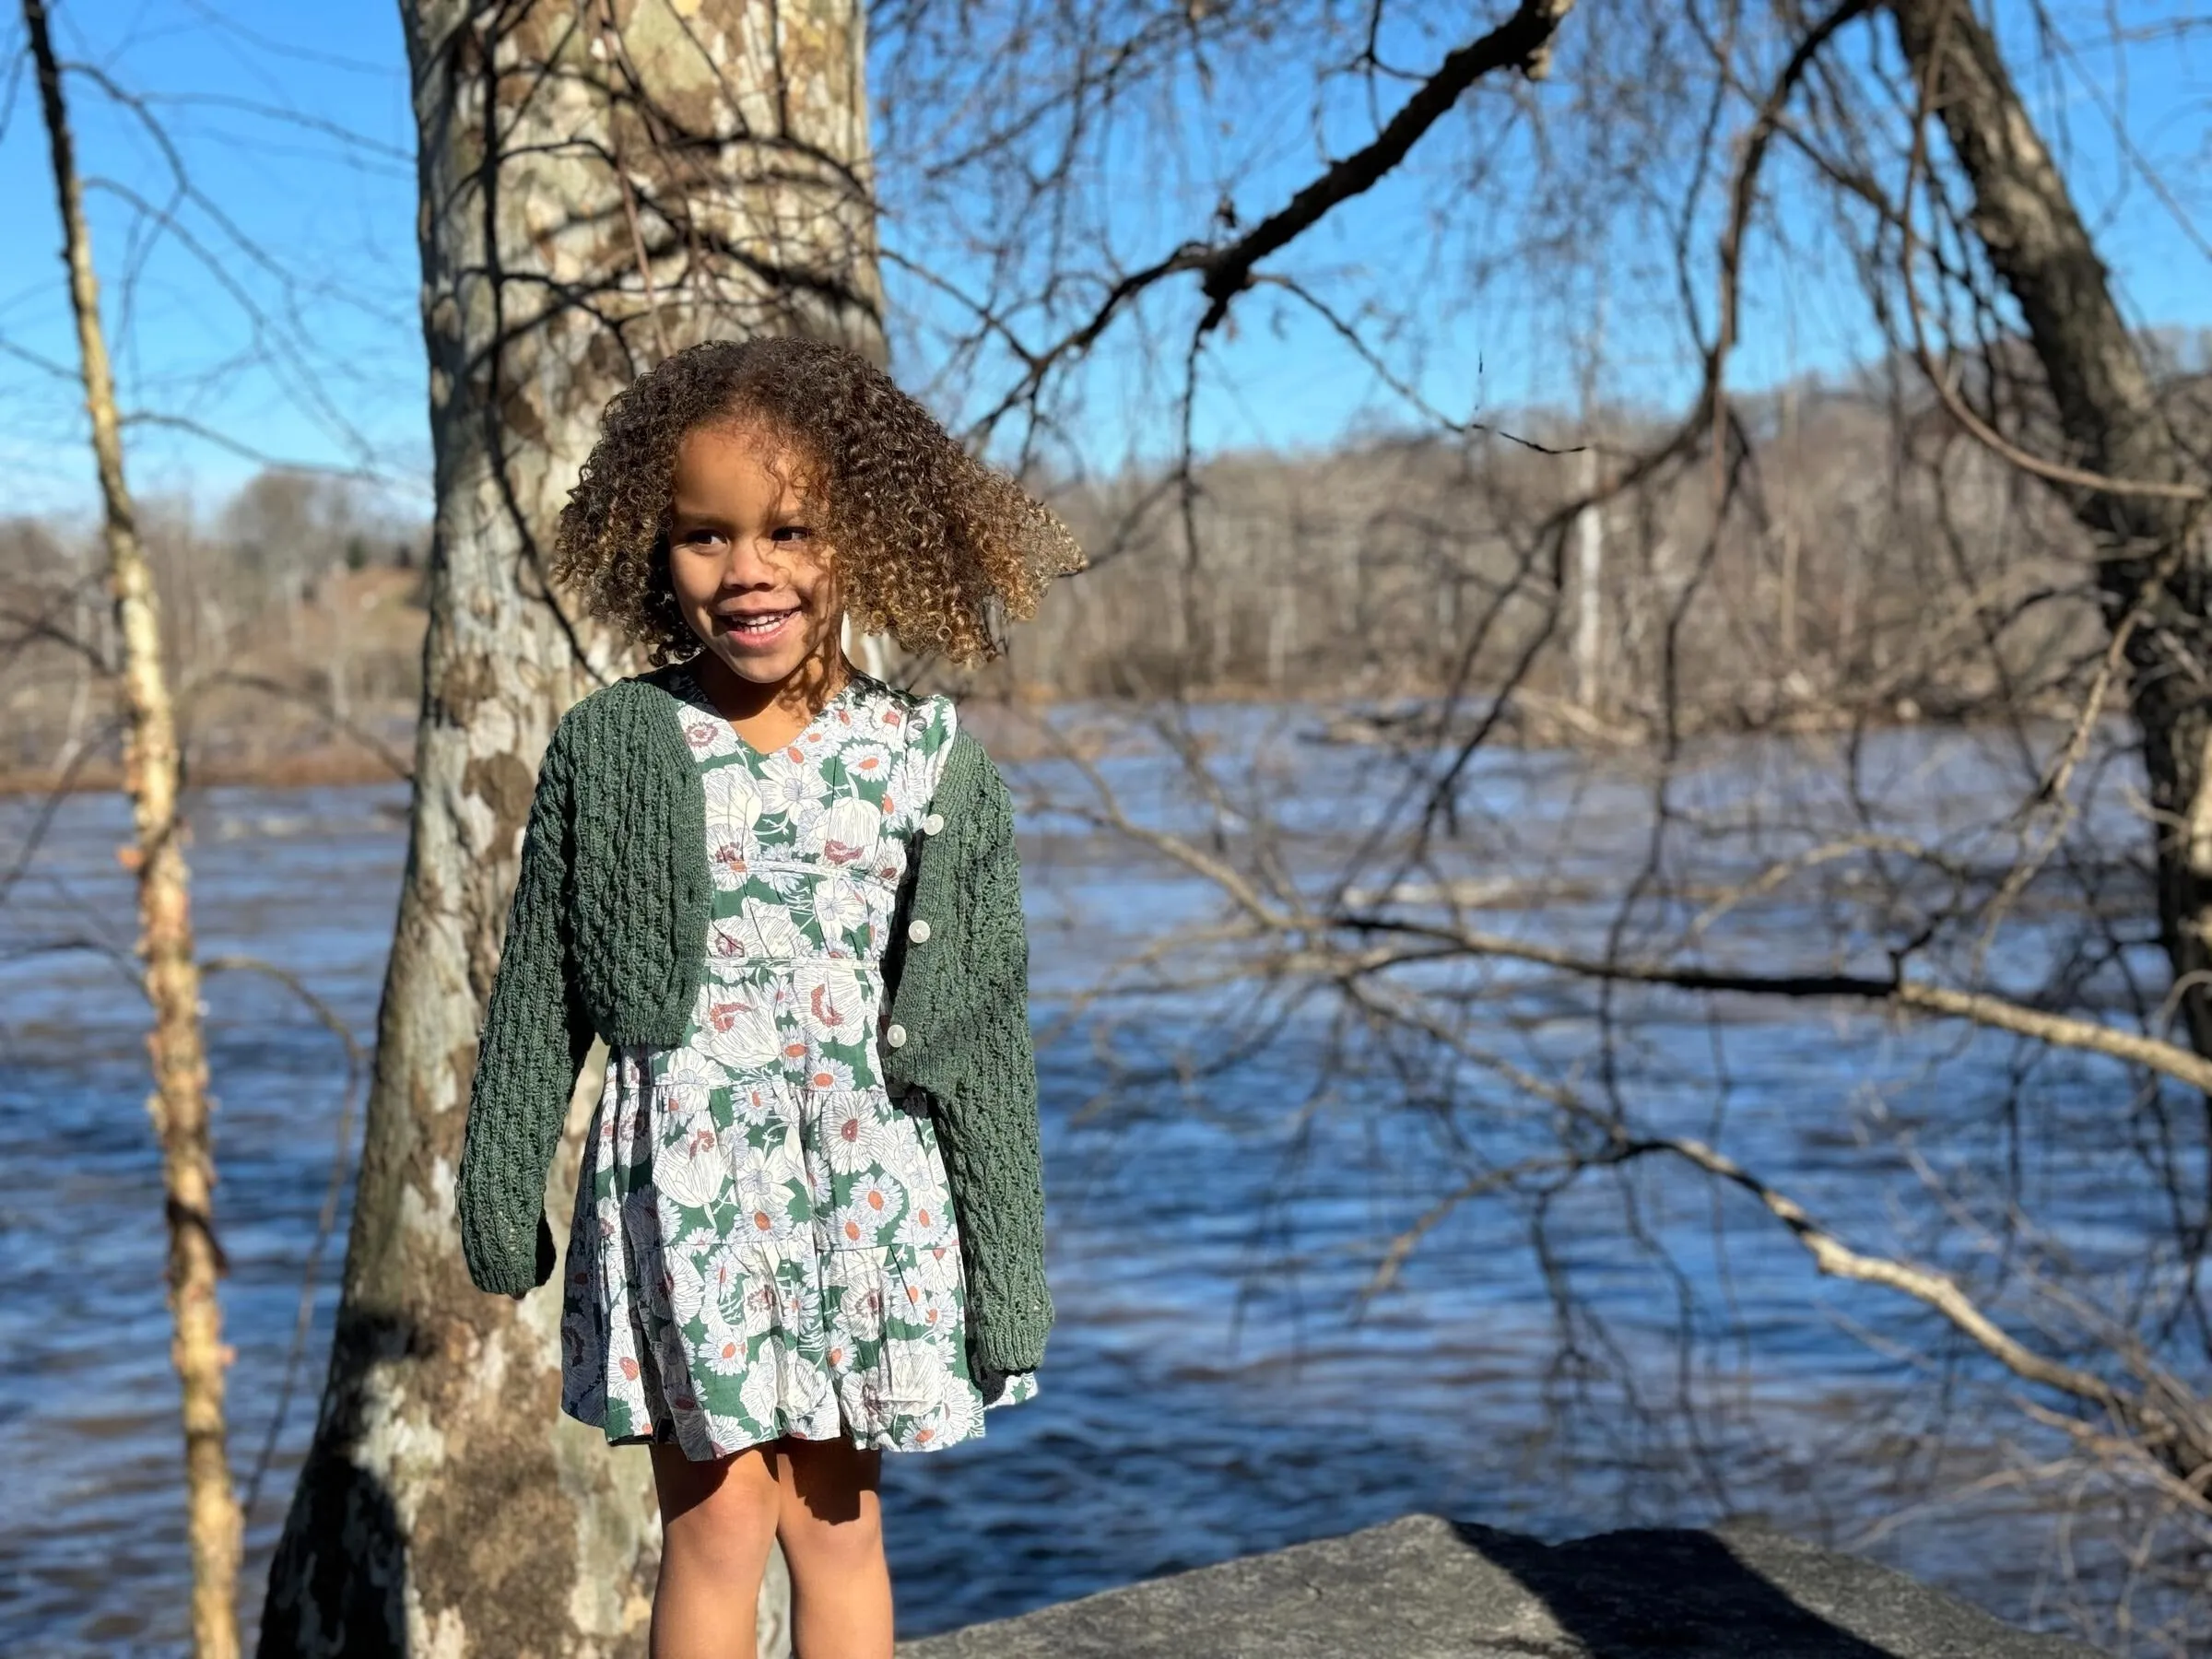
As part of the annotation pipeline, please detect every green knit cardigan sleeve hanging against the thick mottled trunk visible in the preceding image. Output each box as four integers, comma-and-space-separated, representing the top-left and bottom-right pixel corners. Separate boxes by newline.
455, 732, 593, 1296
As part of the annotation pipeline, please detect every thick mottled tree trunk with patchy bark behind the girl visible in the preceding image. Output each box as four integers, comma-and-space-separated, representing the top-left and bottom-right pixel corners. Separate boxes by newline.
261, 0, 880, 1659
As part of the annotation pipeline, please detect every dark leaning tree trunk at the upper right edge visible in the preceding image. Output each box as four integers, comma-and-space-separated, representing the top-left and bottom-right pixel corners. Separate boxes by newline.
1889, 0, 2212, 1055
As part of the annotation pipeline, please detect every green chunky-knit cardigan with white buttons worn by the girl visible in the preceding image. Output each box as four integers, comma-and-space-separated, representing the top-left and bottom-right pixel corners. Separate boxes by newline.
455, 675, 1053, 1373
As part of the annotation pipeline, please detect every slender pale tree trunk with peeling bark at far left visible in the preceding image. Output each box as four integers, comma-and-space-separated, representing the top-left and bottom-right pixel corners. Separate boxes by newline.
22, 0, 241, 1659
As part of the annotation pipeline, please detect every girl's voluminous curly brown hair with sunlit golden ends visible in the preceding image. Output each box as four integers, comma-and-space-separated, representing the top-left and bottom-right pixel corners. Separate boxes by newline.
553, 336, 1084, 664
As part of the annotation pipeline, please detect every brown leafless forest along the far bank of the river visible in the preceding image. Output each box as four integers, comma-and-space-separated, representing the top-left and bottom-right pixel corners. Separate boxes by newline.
17, 358, 2203, 787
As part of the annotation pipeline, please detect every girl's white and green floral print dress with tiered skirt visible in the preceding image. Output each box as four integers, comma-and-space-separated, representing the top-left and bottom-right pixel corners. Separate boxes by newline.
562, 670, 1035, 1460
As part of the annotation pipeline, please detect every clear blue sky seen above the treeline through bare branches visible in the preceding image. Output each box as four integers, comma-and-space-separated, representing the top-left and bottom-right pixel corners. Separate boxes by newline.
0, 0, 2212, 513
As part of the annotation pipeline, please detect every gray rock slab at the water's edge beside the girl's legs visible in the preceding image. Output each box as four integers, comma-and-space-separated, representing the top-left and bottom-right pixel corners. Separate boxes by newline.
898, 1515, 2095, 1659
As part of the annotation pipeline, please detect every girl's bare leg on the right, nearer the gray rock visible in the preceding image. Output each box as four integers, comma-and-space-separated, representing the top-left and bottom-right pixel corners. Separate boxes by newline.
770, 1438, 891, 1659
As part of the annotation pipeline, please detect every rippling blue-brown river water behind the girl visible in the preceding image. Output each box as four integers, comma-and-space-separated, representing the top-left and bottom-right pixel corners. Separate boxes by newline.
0, 732, 2190, 1659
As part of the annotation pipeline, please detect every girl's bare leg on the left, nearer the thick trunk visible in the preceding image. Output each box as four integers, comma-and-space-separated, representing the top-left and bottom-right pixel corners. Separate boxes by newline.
651, 1447, 782, 1659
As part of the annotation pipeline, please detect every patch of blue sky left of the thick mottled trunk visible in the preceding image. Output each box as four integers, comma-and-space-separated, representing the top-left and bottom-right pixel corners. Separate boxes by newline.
0, 0, 425, 511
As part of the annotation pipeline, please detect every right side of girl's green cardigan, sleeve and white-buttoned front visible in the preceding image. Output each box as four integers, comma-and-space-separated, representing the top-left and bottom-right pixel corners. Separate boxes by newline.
887, 732, 1053, 1373
